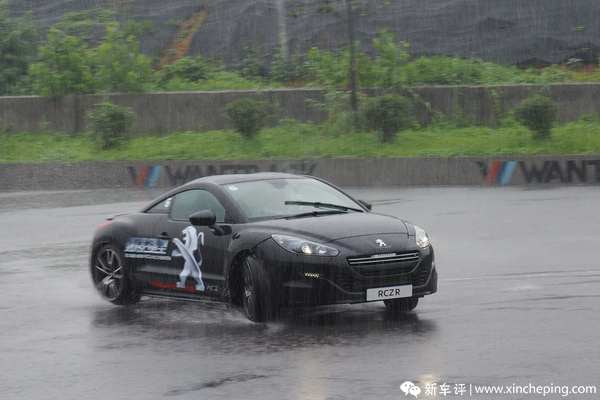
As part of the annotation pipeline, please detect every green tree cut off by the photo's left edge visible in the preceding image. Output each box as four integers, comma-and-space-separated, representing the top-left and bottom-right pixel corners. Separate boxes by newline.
0, 0, 36, 95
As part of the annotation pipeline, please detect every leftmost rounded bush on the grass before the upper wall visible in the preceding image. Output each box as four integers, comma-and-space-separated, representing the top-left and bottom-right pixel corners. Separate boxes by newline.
86, 102, 135, 150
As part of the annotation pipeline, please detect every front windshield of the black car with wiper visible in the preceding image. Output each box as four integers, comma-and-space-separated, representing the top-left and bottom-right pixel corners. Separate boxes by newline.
223, 178, 363, 221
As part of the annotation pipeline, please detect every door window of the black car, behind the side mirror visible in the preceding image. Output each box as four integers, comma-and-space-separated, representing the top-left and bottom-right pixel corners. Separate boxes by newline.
169, 189, 227, 223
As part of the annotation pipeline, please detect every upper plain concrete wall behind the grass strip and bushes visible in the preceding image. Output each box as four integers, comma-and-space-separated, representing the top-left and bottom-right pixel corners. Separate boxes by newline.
0, 83, 600, 133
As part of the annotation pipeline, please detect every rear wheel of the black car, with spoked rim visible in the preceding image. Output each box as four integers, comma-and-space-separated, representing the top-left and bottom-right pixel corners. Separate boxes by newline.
91, 244, 140, 305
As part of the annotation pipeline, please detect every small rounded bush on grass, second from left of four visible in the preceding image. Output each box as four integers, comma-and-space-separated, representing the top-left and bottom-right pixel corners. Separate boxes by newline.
223, 98, 269, 139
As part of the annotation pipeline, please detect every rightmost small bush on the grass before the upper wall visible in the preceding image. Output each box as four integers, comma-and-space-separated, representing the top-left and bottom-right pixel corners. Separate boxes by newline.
514, 96, 558, 139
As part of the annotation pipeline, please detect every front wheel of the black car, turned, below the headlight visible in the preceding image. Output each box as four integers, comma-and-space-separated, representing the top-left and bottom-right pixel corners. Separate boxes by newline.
242, 257, 272, 322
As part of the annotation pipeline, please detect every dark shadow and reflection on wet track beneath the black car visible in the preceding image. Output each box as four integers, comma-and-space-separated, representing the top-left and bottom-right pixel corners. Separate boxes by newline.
93, 299, 437, 352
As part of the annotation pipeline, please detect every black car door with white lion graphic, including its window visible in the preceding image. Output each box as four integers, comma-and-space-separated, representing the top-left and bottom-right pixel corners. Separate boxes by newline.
157, 189, 229, 296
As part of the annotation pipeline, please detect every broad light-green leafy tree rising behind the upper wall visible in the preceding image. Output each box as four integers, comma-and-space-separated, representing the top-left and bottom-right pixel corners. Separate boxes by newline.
29, 12, 152, 98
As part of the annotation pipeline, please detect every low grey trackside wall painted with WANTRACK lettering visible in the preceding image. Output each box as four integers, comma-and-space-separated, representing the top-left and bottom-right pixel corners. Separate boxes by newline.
0, 155, 600, 192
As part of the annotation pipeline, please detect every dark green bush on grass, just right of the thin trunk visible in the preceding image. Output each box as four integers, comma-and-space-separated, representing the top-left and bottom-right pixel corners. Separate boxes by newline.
363, 94, 413, 143
